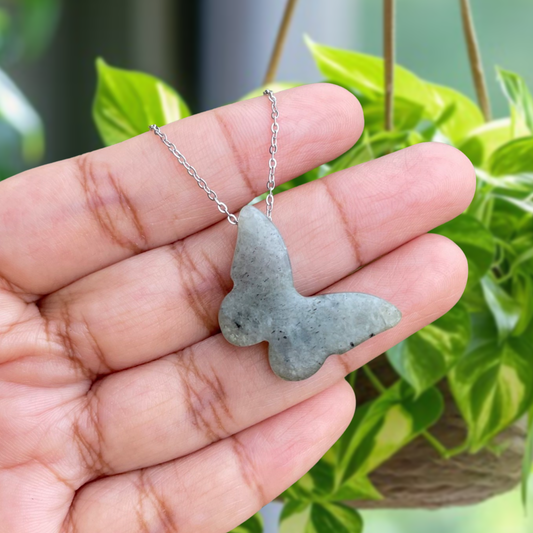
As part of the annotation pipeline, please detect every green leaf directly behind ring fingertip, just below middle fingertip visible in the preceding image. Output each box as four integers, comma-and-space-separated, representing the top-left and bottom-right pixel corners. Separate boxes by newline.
432, 214, 496, 286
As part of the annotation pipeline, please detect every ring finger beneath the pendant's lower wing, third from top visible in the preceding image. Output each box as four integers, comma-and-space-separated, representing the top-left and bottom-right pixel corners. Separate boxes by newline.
71, 234, 467, 481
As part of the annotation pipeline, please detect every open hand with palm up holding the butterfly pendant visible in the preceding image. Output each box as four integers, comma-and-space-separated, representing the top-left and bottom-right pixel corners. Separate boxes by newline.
0, 84, 475, 533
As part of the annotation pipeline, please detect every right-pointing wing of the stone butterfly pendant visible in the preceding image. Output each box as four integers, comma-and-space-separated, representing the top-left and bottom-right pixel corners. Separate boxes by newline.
267, 293, 401, 381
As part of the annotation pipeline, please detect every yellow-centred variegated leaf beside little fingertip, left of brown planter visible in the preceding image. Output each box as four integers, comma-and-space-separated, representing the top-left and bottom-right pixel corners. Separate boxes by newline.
335, 381, 443, 486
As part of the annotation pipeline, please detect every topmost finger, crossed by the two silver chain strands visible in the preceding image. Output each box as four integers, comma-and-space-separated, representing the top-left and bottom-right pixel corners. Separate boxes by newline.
0, 84, 363, 294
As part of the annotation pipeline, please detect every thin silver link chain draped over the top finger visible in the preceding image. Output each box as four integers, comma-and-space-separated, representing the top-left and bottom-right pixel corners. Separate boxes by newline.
150, 89, 279, 224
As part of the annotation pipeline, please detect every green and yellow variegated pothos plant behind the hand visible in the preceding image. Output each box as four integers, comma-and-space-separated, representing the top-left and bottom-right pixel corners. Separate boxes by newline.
89, 38, 533, 533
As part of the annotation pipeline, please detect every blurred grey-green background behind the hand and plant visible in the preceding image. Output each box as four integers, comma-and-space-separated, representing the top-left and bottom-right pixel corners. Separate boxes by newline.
0, 0, 533, 533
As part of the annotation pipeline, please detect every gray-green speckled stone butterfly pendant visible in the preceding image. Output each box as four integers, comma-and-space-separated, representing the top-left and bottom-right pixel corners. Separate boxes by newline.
218, 206, 401, 381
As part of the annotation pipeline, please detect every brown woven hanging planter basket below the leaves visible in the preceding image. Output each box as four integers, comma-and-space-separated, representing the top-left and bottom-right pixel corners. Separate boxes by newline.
347, 357, 527, 509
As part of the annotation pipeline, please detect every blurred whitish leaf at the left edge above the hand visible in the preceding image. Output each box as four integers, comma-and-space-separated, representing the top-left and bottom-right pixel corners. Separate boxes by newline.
0, 70, 44, 163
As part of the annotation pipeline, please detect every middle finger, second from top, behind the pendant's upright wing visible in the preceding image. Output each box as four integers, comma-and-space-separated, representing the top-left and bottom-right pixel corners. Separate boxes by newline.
41, 144, 475, 380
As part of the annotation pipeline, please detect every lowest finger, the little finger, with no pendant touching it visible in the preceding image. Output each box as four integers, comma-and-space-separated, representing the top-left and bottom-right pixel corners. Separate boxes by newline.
66, 382, 355, 533
